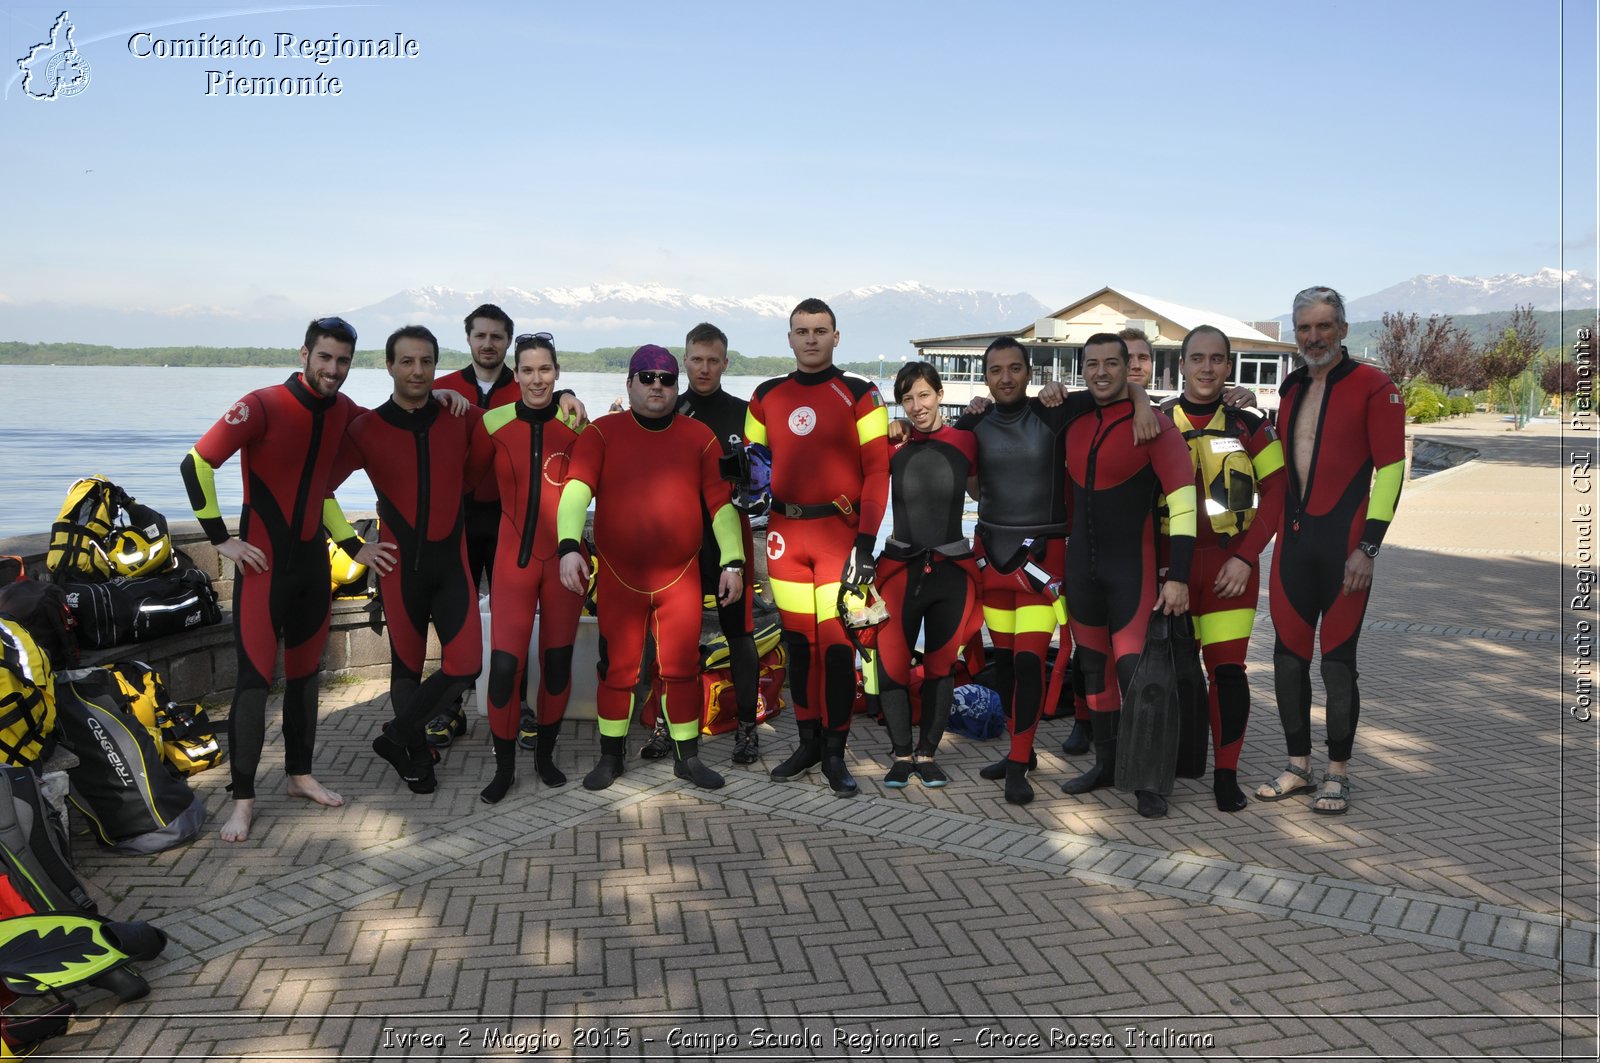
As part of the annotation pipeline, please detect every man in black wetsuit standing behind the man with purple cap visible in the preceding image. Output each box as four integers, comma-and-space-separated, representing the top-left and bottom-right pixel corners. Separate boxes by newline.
640, 322, 762, 764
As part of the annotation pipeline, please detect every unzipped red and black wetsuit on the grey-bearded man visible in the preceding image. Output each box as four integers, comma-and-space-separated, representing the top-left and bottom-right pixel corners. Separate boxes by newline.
1262, 352, 1405, 762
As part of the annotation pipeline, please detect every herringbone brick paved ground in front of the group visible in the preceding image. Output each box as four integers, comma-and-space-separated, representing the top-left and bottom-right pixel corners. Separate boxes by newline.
21, 416, 1600, 1060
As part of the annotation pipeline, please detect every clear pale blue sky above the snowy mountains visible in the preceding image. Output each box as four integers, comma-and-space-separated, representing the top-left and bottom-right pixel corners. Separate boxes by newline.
0, 0, 1595, 317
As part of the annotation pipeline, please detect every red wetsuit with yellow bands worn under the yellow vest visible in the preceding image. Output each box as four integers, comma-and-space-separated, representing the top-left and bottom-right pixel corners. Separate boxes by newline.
1162, 399, 1285, 772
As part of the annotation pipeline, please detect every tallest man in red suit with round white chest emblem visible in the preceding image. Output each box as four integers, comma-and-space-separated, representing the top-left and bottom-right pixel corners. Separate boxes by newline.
744, 299, 890, 797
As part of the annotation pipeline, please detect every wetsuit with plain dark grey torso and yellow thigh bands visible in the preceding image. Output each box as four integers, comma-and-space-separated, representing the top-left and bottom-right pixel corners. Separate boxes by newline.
957, 391, 1094, 764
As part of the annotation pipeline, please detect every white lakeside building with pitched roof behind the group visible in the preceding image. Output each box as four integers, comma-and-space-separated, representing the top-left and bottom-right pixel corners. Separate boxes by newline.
910, 287, 1296, 410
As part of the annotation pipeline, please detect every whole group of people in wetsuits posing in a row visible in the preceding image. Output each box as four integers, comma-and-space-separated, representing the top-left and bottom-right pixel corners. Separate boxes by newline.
182, 288, 1405, 840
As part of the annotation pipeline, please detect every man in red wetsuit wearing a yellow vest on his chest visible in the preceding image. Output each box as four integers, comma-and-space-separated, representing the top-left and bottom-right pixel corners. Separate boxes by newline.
1162, 325, 1283, 812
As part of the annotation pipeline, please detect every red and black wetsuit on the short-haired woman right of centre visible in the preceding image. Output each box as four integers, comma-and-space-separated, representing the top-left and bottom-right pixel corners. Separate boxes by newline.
877, 426, 982, 757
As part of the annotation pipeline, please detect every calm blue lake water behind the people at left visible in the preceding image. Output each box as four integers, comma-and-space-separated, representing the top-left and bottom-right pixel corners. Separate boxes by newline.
0, 365, 765, 538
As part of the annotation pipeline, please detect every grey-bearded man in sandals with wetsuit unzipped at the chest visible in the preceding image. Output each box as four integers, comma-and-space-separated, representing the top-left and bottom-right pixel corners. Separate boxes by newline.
1256, 288, 1405, 815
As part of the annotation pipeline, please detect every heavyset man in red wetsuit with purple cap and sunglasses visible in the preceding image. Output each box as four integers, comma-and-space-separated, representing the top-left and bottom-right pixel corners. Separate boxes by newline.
557, 344, 744, 789
